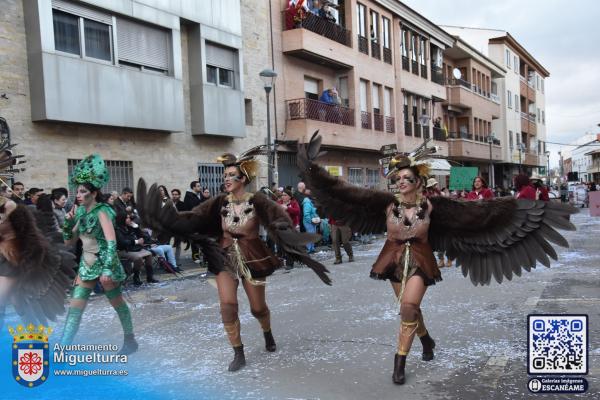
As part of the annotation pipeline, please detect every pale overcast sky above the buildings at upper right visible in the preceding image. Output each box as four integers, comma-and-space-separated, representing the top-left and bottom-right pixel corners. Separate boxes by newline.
402, 0, 600, 166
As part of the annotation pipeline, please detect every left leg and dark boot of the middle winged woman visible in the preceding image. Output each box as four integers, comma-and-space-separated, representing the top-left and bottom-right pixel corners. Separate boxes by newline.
217, 272, 246, 371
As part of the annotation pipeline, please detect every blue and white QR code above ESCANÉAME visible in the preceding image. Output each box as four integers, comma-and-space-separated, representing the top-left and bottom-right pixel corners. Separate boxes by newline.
528, 315, 587, 375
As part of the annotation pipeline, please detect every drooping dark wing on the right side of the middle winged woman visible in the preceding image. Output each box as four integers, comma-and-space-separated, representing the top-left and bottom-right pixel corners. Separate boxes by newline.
252, 192, 331, 285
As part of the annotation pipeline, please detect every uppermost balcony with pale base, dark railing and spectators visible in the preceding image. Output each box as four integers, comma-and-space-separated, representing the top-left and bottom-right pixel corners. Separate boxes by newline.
282, 11, 355, 70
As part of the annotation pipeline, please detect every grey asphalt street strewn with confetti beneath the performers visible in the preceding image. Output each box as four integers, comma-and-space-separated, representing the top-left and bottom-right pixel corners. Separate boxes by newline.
56, 210, 600, 400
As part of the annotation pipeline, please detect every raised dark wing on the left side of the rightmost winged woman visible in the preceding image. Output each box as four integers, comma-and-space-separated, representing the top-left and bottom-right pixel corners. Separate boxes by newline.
297, 131, 395, 233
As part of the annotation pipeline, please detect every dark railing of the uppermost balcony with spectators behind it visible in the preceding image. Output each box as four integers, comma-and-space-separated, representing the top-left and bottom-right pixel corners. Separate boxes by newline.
283, 9, 352, 47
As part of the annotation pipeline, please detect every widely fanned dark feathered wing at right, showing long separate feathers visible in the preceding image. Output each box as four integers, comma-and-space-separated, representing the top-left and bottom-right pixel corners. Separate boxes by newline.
429, 197, 577, 285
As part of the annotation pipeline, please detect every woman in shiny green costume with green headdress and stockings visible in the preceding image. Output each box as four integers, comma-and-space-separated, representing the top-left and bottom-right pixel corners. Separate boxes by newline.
61, 154, 138, 354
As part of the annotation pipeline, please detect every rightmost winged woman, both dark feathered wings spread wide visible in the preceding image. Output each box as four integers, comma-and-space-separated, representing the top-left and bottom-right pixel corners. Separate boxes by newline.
297, 131, 577, 384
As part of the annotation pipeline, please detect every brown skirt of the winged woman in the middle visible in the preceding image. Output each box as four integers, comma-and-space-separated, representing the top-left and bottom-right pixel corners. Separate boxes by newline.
208, 238, 281, 278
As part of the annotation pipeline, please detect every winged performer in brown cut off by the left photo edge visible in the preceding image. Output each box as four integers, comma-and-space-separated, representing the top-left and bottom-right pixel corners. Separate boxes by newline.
0, 141, 75, 330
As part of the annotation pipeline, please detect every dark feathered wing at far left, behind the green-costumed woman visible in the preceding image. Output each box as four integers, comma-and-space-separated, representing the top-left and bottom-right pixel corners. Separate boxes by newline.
3, 205, 76, 324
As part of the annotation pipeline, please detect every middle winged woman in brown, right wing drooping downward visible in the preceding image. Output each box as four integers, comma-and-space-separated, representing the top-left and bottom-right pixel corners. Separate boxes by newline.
137, 146, 331, 371
